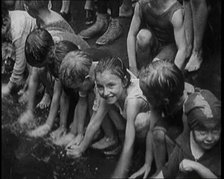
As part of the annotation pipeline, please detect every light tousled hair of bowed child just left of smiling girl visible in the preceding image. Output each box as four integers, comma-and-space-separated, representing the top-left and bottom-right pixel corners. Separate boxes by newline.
59, 50, 92, 88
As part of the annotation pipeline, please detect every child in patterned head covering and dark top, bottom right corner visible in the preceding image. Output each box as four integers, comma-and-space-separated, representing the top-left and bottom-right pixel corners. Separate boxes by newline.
153, 90, 221, 178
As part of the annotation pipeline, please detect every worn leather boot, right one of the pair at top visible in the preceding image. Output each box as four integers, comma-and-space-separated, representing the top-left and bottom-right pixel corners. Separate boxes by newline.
96, 18, 123, 45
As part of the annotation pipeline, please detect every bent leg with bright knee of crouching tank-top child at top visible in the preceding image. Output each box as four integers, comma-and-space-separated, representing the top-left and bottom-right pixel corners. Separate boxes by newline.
136, 29, 153, 70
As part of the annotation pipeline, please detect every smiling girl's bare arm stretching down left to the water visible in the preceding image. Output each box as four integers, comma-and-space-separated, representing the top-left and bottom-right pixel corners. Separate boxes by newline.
67, 98, 108, 158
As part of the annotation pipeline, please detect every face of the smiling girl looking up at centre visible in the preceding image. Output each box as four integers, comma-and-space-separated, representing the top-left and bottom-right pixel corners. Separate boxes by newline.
96, 70, 125, 104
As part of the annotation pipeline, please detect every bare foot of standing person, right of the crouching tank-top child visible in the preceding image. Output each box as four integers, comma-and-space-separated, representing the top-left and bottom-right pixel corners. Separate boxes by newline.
185, 52, 203, 72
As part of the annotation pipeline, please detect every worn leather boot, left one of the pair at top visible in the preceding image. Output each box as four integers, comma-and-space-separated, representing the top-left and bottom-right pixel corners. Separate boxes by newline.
79, 14, 108, 39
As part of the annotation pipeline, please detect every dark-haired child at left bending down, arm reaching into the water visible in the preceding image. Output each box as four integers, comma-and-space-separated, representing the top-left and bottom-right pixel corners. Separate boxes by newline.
19, 28, 88, 127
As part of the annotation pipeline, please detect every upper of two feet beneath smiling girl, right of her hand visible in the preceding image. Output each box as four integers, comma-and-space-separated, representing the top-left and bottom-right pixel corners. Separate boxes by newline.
92, 136, 118, 150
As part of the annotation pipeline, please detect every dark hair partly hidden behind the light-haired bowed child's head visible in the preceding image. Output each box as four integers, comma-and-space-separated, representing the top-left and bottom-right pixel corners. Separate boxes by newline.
47, 40, 78, 78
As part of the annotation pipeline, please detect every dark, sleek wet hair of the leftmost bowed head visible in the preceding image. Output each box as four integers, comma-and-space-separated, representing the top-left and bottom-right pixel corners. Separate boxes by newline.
25, 28, 54, 67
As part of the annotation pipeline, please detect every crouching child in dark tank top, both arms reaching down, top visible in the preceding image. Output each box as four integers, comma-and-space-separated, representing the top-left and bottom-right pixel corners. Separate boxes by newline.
127, 0, 186, 75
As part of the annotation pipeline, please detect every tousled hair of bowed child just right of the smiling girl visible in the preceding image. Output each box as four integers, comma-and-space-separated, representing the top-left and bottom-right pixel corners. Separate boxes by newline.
139, 60, 184, 104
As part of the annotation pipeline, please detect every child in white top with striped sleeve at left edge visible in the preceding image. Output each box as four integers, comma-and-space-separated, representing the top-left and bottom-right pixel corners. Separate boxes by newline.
2, 4, 36, 97
